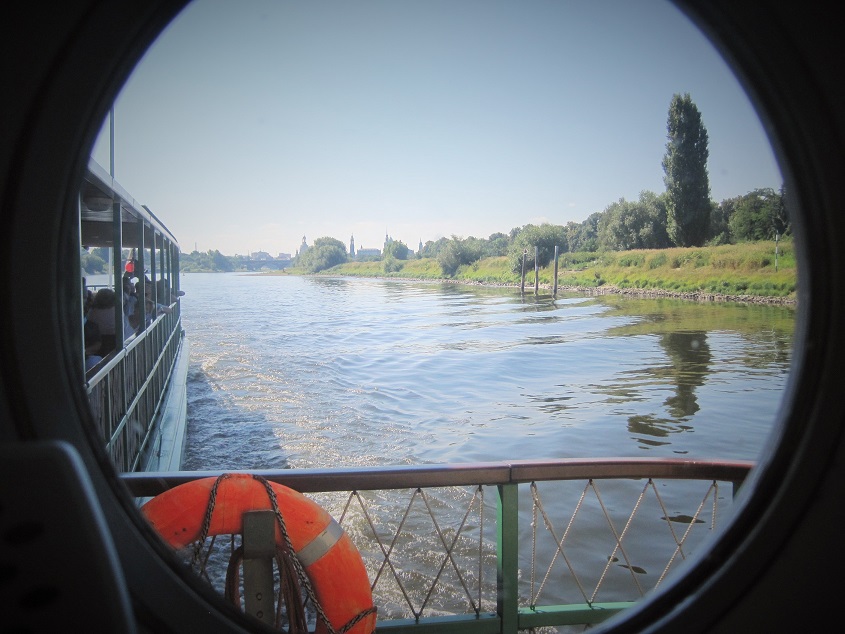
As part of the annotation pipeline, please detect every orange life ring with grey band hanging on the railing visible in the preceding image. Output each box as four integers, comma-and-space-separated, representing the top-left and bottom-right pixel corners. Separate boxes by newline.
141, 473, 376, 634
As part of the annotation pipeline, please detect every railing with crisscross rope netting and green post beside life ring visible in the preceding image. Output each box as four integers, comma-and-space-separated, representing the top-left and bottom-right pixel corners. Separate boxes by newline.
123, 458, 753, 633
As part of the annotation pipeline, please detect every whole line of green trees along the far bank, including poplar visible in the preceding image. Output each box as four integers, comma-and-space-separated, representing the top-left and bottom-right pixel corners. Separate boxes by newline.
95, 94, 791, 277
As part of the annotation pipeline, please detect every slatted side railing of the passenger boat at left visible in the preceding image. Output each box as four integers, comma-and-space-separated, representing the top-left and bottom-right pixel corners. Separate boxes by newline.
86, 301, 183, 471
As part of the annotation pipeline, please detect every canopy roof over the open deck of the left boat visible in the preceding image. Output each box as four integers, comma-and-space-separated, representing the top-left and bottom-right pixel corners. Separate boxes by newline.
79, 160, 179, 249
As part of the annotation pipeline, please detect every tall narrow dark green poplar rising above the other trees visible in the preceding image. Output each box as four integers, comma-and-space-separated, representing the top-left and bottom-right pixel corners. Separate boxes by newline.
663, 93, 710, 247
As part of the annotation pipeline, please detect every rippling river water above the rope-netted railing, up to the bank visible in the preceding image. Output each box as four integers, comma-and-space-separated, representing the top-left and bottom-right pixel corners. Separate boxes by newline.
182, 274, 794, 469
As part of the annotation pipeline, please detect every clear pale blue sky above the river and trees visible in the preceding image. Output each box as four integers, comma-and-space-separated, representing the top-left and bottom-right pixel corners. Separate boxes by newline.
92, 0, 782, 256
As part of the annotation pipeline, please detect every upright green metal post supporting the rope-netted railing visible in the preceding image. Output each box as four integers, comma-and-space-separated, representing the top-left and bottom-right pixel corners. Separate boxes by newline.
496, 483, 519, 634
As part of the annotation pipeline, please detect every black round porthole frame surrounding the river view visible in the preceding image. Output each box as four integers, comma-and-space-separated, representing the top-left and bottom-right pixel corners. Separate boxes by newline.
0, 0, 845, 632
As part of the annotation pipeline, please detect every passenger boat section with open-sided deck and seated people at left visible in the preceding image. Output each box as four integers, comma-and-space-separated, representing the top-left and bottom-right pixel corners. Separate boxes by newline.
76, 161, 188, 472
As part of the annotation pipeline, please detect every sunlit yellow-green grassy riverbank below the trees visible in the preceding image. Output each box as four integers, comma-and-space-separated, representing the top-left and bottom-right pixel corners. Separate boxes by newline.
280, 241, 797, 302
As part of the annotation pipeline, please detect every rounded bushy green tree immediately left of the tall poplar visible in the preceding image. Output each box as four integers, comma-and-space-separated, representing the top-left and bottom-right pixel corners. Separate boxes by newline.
598, 191, 669, 251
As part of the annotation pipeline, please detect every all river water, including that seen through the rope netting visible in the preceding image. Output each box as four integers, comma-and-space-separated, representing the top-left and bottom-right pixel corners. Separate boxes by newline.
176, 274, 795, 618
